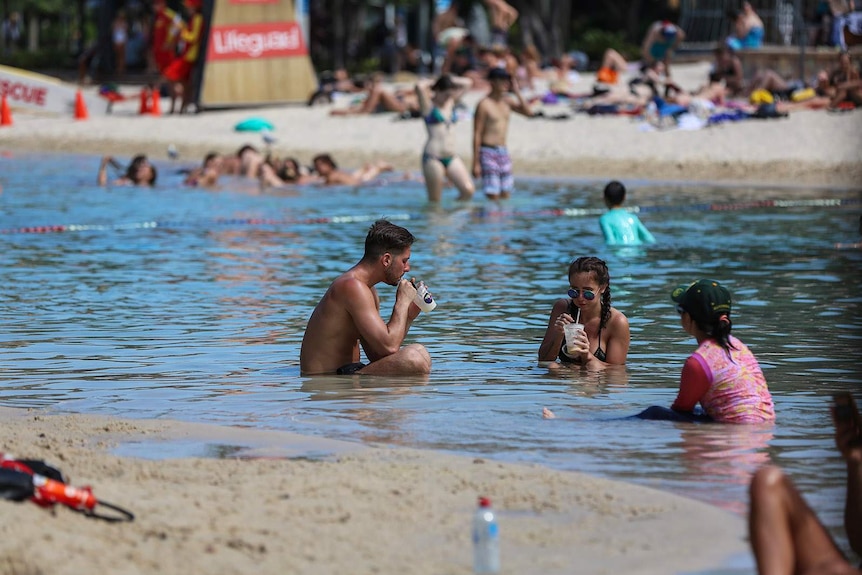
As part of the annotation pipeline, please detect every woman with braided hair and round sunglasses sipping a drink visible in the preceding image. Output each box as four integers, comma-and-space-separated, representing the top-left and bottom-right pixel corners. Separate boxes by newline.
539, 257, 631, 370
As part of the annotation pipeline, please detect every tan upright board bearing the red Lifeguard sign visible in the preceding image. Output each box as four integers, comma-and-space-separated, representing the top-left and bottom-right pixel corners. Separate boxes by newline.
198, 0, 317, 108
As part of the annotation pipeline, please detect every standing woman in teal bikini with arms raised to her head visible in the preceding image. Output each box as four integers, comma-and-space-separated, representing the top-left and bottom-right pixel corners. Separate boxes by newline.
416, 75, 476, 202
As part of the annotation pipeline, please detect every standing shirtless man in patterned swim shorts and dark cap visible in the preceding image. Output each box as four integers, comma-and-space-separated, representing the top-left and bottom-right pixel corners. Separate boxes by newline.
473, 68, 533, 199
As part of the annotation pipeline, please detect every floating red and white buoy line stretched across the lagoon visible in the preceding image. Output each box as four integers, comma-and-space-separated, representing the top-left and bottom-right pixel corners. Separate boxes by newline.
0, 198, 862, 235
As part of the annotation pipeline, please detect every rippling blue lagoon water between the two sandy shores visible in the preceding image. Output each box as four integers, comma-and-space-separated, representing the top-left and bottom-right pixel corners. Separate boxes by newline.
5, 154, 862, 564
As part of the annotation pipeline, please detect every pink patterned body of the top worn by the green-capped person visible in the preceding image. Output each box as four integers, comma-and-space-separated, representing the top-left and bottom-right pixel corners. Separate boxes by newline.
692, 336, 775, 423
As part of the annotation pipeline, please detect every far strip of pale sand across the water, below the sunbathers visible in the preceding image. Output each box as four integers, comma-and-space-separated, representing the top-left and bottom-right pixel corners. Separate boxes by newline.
0, 62, 862, 189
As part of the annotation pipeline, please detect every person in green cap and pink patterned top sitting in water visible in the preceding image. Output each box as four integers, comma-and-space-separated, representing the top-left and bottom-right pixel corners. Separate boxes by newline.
639, 279, 775, 423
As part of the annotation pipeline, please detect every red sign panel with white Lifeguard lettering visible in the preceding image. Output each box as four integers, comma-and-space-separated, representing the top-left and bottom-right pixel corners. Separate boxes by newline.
207, 22, 308, 62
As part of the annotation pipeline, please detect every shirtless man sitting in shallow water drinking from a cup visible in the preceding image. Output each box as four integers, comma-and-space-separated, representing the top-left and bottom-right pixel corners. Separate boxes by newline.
299, 220, 431, 375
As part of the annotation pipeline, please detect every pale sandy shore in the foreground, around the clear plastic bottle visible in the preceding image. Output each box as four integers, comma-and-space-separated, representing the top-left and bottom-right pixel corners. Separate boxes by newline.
0, 409, 747, 575
